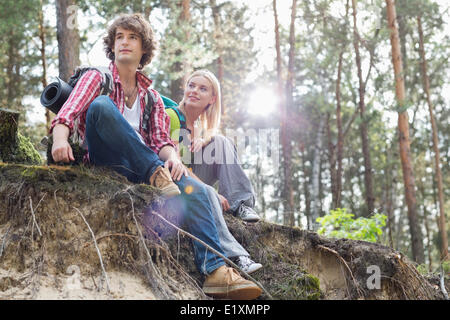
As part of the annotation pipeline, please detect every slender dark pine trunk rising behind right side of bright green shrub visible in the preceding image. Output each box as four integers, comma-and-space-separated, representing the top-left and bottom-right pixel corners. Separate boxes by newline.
352, 0, 375, 216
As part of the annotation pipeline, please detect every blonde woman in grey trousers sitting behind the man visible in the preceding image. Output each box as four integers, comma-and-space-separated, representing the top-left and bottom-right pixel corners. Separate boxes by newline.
166, 70, 262, 273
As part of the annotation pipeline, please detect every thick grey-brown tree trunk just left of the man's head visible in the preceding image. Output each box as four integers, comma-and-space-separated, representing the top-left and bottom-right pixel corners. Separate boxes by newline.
56, 0, 80, 81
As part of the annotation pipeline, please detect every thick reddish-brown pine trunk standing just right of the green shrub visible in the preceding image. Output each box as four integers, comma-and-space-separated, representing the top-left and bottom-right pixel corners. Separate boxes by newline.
386, 0, 425, 263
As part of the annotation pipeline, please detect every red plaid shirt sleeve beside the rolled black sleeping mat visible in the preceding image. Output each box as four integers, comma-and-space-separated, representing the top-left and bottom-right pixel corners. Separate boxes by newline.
50, 70, 102, 134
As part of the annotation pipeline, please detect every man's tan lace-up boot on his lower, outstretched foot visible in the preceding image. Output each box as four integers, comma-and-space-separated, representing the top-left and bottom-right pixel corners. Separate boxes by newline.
203, 266, 262, 300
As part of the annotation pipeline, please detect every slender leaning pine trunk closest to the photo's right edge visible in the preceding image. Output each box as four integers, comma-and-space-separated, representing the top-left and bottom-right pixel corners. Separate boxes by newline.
417, 16, 449, 260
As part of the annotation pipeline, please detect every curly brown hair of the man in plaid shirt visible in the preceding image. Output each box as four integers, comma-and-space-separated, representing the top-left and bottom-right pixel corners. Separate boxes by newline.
103, 13, 157, 69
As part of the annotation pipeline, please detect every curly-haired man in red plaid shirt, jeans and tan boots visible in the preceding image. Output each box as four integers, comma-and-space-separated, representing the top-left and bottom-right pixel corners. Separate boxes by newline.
52, 14, 261, 299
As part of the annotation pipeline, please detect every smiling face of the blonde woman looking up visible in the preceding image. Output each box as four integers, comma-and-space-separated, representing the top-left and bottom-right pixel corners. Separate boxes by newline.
184, 76, 216, 110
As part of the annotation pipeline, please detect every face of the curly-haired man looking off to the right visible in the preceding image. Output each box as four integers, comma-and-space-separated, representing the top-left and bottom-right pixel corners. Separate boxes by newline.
113, 27, 144, 64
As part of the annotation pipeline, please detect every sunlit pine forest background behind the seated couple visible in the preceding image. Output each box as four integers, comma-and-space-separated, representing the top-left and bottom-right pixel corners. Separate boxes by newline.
0, 0, 450, 271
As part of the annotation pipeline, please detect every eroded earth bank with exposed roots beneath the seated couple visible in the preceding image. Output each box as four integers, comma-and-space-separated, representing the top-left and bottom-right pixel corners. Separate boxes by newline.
0, 162, 448, 299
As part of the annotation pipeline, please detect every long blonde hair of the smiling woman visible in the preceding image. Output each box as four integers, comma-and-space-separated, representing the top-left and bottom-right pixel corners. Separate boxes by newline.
179, 69, 222, 142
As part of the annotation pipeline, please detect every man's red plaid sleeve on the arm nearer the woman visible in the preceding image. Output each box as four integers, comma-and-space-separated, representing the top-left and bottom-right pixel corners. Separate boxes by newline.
150, 89, 175, 154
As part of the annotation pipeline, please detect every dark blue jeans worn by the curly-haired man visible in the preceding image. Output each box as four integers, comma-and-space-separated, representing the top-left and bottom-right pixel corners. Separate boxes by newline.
86, 96, 225, 274
